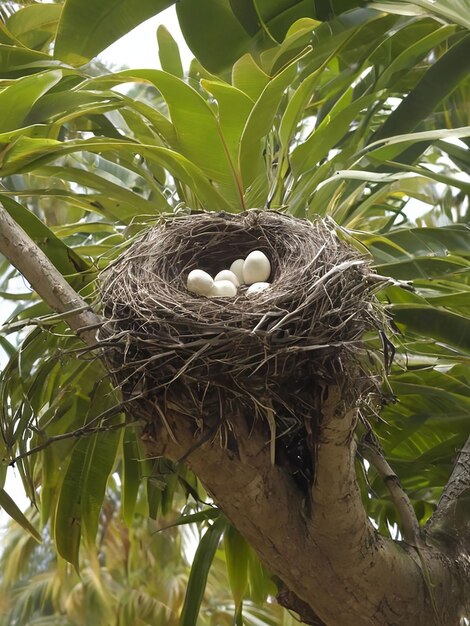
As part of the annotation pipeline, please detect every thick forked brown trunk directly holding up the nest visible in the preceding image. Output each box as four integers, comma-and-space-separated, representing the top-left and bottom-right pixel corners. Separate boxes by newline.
144, 390, 461, 626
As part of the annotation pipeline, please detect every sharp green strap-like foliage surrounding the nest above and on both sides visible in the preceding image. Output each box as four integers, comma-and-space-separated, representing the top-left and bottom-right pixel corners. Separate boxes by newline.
0, 0, 470, 623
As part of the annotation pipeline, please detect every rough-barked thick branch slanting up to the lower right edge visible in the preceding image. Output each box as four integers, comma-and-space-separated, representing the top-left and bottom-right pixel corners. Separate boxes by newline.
426, 437, 470, 553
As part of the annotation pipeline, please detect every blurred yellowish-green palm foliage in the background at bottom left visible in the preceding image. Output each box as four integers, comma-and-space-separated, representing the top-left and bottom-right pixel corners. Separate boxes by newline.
0, 488, 282, 626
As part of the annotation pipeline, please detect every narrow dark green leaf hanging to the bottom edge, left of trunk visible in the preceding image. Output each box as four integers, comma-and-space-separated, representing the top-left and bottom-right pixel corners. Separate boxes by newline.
179, 516, 227, 626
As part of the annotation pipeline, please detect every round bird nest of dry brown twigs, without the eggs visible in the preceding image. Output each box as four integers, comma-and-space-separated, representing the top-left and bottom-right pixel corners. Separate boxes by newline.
100, 210, 387, 482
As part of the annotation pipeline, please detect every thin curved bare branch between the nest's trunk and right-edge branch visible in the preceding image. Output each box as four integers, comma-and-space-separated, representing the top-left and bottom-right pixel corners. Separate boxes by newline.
358, 441, 423, 547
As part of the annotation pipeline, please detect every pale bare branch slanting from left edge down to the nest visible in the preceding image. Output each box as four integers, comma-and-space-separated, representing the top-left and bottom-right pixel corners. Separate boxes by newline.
0, 204, 102, 345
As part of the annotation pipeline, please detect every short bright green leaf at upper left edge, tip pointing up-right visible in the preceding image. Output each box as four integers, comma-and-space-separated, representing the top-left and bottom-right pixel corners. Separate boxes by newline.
0, 70, 62, 133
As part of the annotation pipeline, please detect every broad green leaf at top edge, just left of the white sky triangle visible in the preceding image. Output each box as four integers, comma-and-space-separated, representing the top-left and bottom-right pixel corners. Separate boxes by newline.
54, 0, 174, 65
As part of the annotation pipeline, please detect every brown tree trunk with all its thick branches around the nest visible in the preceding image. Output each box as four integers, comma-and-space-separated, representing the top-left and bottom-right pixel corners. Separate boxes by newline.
0, 206, 470, 626
